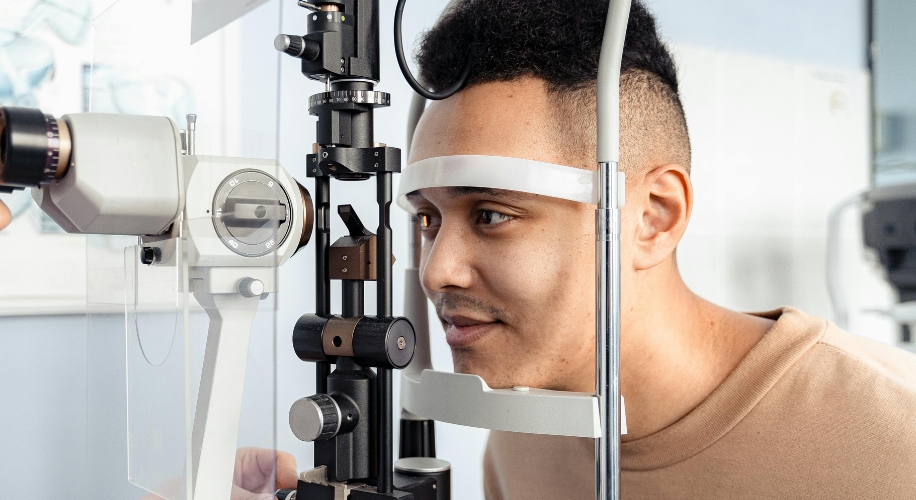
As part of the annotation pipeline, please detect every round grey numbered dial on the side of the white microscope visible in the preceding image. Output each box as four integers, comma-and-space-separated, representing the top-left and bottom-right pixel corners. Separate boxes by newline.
213, 170, 293, 257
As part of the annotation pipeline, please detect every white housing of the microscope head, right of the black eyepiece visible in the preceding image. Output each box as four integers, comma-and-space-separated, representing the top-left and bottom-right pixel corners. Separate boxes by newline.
32, 113, 184, 235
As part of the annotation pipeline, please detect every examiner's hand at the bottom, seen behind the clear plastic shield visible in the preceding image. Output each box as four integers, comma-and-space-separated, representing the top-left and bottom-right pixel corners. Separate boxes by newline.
140, 448, 299, 500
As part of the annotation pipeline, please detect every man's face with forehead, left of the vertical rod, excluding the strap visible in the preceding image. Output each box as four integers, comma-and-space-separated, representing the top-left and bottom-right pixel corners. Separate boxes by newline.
410, 79, 595, 392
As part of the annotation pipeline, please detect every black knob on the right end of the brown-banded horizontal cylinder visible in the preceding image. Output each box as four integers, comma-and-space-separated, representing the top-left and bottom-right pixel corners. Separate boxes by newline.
353, 316, 417, 369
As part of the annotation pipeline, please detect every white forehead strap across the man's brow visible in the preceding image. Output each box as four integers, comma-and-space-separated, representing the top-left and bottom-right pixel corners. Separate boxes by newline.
397, 155, 598, 213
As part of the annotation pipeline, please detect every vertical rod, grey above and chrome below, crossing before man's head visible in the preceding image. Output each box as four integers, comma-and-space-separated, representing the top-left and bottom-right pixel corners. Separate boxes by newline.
595, 0, 630, 500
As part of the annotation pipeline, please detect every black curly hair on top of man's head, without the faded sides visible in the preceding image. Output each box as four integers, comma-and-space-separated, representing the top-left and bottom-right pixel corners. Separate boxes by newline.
417, 0, 678, 94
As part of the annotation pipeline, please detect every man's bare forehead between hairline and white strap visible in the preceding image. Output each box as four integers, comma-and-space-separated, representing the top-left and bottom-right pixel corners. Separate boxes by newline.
409, 78, 568, 164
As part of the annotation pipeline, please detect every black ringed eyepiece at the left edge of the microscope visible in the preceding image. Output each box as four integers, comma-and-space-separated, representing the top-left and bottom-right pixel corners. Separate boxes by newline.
0, 108, 72, 188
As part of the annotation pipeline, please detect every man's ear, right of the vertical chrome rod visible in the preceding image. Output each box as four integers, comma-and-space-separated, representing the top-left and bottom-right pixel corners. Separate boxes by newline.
633, 164, 693, 271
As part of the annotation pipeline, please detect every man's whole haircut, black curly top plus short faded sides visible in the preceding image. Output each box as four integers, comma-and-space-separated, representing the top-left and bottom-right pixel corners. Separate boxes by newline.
417, 0, 690, 174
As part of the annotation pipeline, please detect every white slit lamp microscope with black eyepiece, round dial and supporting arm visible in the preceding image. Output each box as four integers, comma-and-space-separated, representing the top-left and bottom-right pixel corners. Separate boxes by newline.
0, 108, 313, 500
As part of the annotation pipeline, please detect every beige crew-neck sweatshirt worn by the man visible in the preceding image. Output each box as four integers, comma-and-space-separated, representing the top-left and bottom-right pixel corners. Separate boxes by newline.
484, 308, 916, 500
